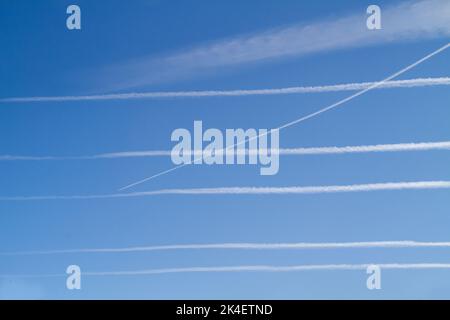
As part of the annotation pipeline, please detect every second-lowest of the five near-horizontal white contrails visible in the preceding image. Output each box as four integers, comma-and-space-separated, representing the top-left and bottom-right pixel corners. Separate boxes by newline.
0, 240, 450, 256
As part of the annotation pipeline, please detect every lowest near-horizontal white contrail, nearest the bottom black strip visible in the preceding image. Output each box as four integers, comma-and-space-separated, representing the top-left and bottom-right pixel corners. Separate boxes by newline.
0, 263, 450, 278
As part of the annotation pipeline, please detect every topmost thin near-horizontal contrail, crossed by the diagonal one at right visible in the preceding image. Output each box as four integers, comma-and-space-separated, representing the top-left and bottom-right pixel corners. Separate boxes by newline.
0, 77, 450, 103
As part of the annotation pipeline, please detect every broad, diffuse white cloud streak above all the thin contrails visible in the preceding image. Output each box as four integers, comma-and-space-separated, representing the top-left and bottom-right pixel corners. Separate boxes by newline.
101, 0, 450, 88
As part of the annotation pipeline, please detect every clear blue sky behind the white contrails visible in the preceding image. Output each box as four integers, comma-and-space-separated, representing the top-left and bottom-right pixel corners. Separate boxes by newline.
0, 0, 450, 299
